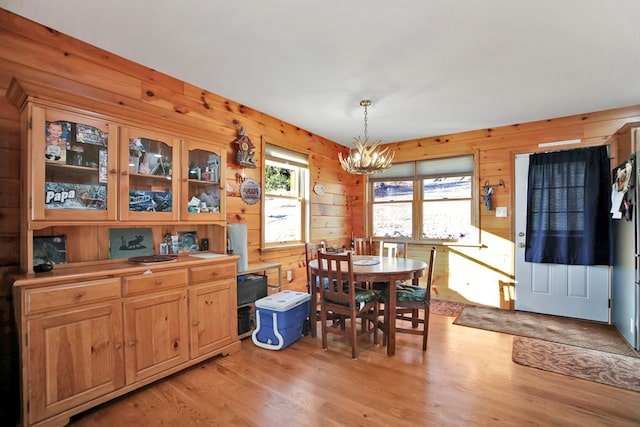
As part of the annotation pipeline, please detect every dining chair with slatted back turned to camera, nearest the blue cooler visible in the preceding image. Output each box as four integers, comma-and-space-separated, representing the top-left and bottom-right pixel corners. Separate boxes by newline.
312, 252, 381, 359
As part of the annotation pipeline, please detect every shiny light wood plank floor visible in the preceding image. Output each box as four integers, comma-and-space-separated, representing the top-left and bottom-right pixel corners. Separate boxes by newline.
71, 315, 640, 427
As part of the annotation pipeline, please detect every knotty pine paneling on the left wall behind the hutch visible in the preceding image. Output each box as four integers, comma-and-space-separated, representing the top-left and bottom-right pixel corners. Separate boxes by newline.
0, 11, 352, 314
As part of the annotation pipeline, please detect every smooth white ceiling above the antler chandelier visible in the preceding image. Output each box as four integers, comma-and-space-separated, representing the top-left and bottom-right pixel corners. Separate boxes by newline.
0, 0, 640, 145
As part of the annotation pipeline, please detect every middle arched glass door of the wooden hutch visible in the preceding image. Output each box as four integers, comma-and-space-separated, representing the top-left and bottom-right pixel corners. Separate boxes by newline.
120, 128, 179, 221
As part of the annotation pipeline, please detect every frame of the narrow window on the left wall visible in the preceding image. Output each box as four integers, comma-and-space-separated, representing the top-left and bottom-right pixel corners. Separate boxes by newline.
261, 142, 310, 249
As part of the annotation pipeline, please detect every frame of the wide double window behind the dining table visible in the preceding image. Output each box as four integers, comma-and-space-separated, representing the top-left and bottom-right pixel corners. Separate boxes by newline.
366, 153, 480, 245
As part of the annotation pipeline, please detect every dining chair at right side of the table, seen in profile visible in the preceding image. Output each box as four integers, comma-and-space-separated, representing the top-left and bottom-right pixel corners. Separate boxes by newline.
395, 248, 436, 351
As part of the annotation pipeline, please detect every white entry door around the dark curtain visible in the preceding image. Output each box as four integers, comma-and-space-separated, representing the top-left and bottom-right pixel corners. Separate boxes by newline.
514, 154, 611, 323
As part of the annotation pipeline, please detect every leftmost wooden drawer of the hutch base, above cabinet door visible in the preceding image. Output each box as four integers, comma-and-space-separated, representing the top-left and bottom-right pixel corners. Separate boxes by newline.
24, 278, 120, 314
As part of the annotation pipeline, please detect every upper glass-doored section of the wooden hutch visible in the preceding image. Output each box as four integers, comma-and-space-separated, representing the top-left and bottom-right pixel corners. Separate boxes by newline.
7, 80, 227, 273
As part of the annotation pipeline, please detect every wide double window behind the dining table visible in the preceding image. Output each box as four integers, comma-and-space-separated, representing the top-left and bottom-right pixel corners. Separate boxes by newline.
369, 155, 475, 241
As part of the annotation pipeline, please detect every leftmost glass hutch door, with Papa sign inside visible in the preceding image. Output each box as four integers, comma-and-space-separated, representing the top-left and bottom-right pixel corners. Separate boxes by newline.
28, 105, 118, 221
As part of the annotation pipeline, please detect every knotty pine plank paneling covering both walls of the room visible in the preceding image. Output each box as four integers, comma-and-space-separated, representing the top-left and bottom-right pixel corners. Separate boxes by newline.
0, 6, 640, 306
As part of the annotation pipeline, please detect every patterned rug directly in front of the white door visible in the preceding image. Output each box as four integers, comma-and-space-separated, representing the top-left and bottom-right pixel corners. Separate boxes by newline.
453, 305, 640, 357
